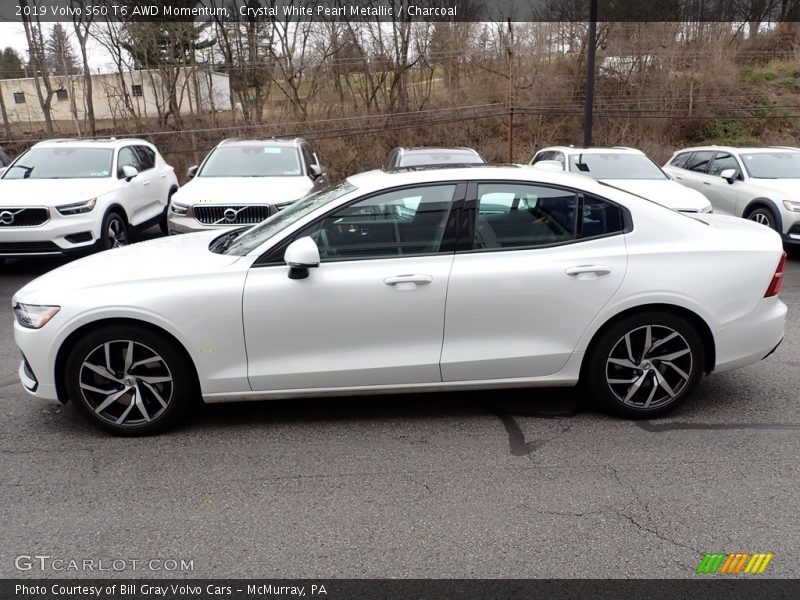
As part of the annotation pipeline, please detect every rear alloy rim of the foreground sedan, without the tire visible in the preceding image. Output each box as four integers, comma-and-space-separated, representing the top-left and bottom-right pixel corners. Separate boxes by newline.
605, 325, 693, 409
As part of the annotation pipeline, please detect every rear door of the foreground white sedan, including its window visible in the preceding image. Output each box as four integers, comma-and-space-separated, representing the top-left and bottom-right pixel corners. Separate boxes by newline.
441, 182, 629, 381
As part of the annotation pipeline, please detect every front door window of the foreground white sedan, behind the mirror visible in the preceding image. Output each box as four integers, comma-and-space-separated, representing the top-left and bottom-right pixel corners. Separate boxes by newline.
298, 184, 456, 261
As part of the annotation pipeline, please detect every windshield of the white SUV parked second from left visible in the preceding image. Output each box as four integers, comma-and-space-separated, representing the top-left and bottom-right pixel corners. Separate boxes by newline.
197, 144, 303, 177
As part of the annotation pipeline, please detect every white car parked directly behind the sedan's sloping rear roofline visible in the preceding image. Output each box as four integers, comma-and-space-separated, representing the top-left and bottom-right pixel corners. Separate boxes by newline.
530, 146, 711, 213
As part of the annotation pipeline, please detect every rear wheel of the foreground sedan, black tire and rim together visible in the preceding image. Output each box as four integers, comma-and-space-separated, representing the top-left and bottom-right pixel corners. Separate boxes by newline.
584, 311, 705, 419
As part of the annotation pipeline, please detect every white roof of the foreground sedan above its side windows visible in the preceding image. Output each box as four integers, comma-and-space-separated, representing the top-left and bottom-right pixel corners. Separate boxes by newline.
347, 164, 606, 194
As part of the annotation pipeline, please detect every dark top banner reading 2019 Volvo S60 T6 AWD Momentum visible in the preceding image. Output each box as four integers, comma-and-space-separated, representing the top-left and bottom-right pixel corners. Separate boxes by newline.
0, 0, 800, 23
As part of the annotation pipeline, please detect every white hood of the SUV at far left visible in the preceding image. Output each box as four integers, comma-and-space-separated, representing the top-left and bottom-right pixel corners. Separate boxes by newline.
0, 177, 119, 207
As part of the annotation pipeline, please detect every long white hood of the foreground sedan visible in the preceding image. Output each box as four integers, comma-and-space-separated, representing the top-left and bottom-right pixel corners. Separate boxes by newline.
15, 231, 241, 304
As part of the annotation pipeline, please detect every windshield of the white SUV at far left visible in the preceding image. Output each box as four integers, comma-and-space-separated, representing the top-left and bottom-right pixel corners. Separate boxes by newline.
3, 146, 114, 179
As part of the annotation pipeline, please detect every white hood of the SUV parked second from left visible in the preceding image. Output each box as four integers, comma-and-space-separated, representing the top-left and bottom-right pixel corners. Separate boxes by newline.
173, 177, 314, 205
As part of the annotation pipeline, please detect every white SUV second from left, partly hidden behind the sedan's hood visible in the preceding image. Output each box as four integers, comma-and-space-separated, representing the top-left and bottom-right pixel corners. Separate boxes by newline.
169, 138, 328, 233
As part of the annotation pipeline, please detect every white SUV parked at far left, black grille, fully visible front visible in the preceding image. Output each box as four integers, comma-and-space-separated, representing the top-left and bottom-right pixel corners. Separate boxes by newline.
0, 138, 178, 262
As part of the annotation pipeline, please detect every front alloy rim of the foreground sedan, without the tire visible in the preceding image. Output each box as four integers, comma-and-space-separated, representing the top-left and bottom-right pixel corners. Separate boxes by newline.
79, 340, 174, 426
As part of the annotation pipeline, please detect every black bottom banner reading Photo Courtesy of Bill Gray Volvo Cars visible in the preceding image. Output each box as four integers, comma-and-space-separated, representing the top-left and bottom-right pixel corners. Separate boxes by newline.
0, 575, 800, 600
